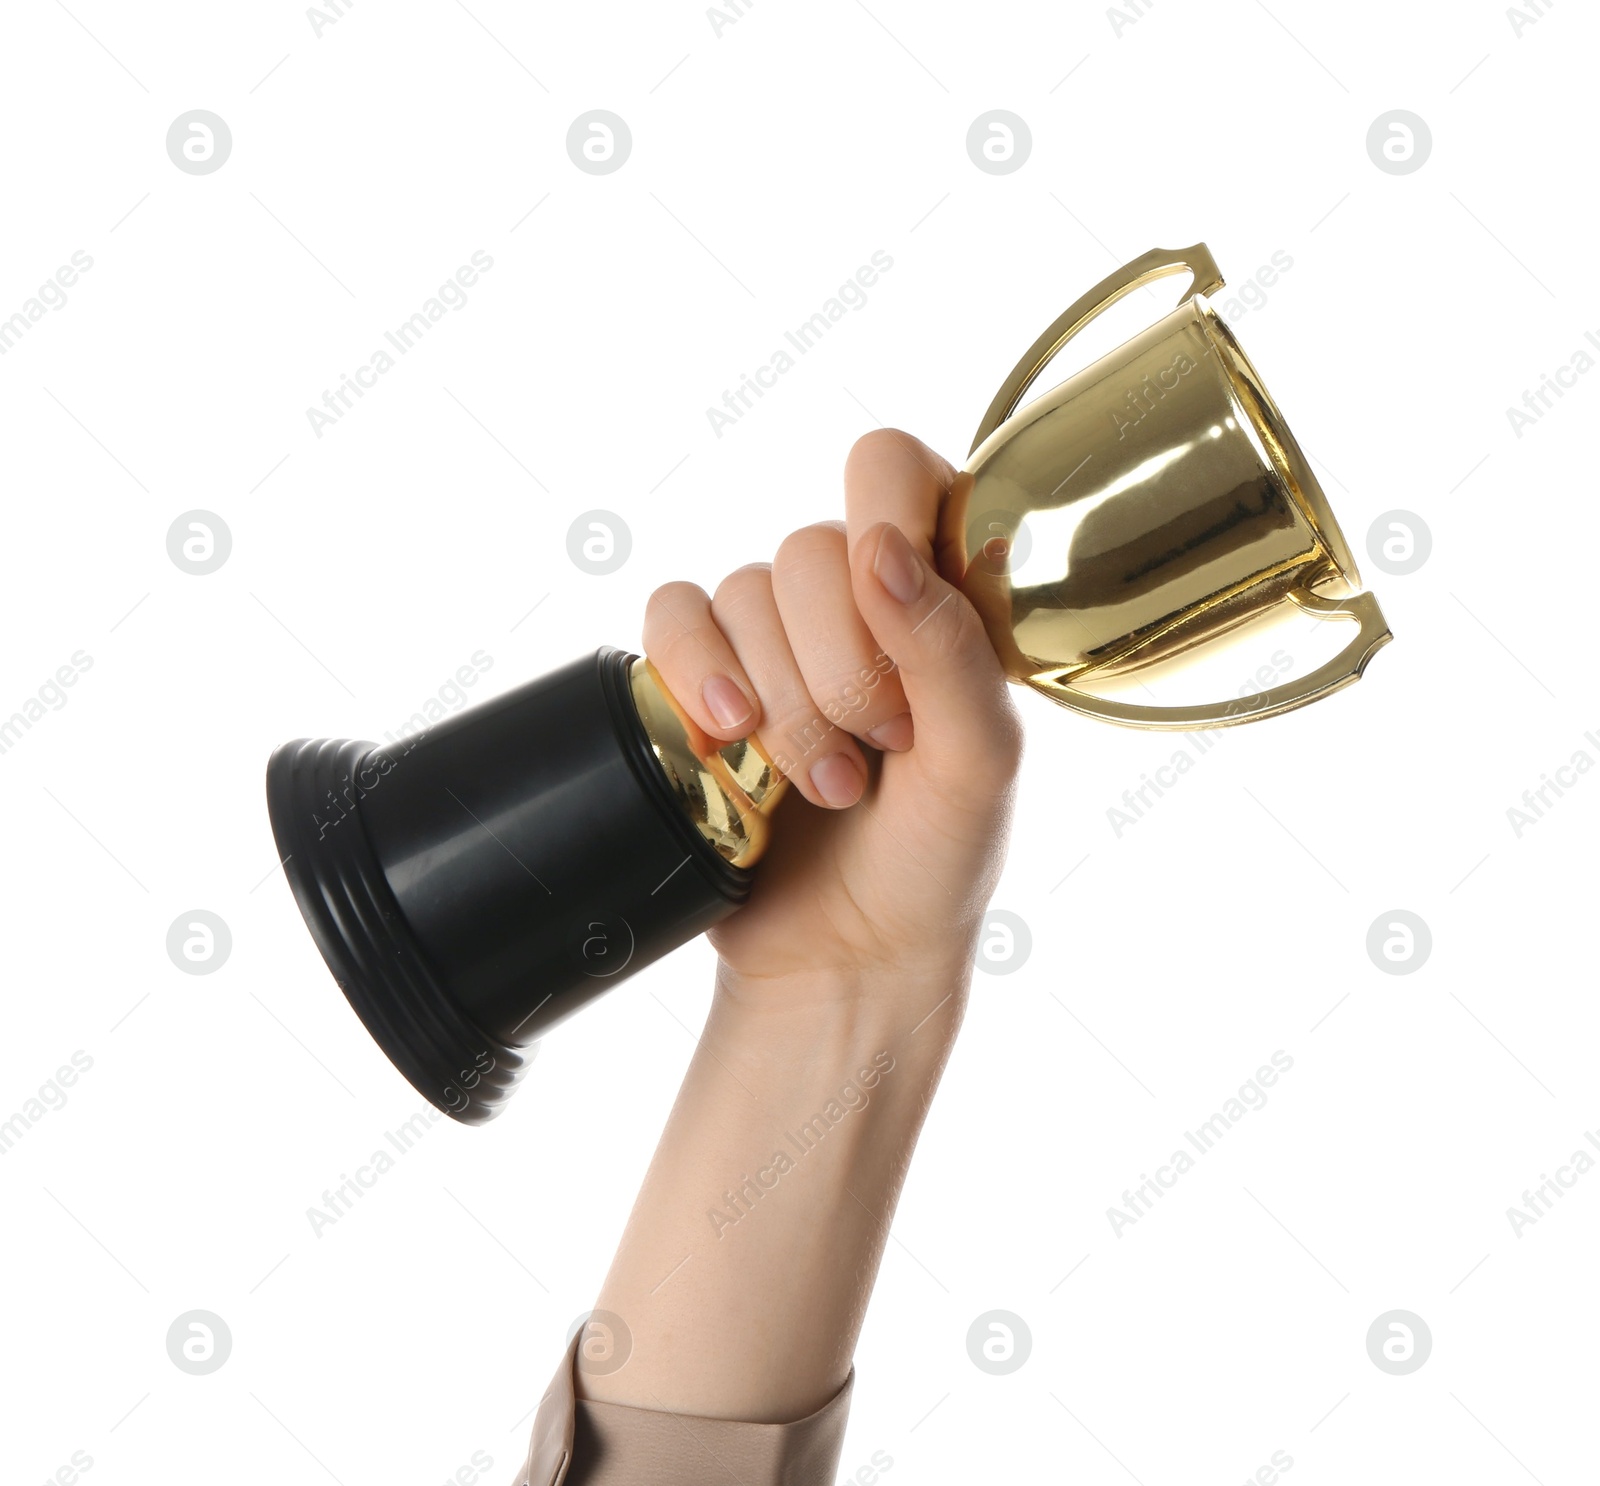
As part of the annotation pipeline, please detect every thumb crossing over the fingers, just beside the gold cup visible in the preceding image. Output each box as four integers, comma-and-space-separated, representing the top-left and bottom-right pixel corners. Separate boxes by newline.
850, 521, 1021, 797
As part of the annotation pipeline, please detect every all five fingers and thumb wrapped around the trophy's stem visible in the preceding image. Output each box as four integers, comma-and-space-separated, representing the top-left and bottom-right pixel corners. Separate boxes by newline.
645, 429, 1021, 813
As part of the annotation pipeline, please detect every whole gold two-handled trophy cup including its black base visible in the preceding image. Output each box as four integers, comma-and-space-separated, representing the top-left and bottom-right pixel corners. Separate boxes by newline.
267, 243, 1390, 1123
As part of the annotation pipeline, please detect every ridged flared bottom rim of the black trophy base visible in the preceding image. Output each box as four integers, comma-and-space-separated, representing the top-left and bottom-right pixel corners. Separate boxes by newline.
267, 737, 531, 1124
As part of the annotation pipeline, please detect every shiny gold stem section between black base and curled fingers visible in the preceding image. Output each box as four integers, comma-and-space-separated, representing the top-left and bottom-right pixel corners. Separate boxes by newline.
629, 657, 789, 867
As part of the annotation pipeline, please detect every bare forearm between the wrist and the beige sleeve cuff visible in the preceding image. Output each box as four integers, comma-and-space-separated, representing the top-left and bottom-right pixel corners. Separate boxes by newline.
579, 968, 966, 1422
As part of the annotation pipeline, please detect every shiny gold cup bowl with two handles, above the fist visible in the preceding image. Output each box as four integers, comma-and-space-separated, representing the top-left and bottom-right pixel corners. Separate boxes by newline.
962, 243, 1390, 728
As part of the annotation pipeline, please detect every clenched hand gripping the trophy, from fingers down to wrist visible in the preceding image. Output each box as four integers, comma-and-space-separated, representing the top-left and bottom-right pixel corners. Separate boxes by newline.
643, 429, 1021, 998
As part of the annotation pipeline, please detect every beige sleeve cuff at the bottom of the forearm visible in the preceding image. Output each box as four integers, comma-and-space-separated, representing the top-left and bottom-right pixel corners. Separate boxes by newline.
515, 1336, 856, 1486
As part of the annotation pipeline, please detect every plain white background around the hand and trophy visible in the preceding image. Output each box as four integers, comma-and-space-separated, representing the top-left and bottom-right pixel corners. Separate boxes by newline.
0, 0, 1600, 1486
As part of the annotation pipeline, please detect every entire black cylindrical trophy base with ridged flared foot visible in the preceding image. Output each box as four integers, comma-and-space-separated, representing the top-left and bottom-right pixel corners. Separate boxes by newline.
267, 649, 750, 1124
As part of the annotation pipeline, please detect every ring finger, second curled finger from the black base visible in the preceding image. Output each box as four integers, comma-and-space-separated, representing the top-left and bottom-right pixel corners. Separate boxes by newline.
712, 563, 867, 809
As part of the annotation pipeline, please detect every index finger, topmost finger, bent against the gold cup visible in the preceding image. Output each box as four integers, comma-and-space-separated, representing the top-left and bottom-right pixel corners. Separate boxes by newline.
845, 429, 971, 582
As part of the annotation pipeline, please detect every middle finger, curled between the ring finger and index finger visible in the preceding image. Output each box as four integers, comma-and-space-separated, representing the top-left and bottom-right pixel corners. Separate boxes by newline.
773, 521, 912, 752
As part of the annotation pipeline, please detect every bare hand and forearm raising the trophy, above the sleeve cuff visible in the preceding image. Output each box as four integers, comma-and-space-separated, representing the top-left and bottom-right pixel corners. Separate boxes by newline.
578, 429, 1021, 1426
